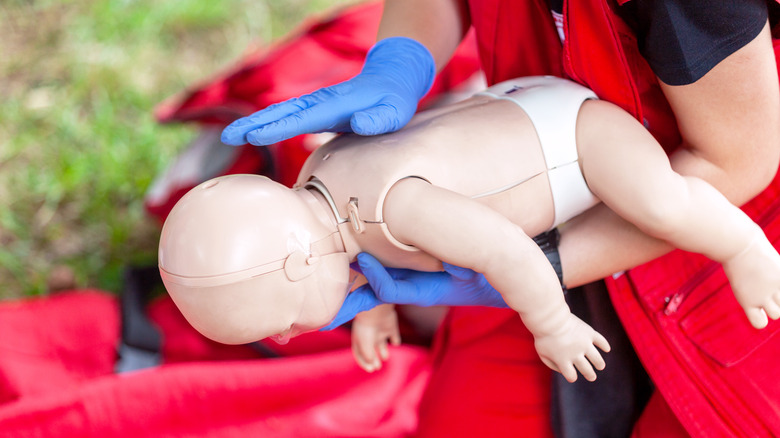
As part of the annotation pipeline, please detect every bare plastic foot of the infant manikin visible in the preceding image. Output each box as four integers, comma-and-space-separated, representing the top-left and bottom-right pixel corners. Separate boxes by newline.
723, 233, 780, 329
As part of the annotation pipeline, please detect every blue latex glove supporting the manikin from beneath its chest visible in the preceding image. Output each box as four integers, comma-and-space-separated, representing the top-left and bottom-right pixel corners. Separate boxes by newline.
322, 253, 509, 330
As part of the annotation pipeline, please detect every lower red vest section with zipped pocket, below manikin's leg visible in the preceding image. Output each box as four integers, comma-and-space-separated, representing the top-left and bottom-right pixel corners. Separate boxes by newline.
607, 169, 780, 437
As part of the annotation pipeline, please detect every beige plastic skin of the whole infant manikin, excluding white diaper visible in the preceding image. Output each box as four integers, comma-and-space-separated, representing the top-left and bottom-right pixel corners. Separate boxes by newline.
159, 77, 780, 381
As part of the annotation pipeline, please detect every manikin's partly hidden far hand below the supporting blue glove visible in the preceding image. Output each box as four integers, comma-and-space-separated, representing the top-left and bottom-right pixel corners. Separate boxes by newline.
352, 304, 401, 373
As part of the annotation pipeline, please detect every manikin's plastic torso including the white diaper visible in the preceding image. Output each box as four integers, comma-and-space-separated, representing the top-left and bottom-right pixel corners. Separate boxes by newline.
296, 77, 597, 270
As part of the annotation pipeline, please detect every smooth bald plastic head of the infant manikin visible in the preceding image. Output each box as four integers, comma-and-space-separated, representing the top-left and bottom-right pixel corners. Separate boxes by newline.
159, 175, 349, 344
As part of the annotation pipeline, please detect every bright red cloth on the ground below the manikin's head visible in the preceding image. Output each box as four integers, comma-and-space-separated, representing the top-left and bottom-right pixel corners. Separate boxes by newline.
0, 291, 430, 437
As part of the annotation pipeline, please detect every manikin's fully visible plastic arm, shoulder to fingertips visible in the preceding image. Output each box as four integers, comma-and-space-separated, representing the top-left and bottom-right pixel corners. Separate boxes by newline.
384, 178, 609, 381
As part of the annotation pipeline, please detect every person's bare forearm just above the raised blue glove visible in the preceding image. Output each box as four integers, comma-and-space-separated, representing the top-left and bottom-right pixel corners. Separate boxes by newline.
377, 0, 469, 70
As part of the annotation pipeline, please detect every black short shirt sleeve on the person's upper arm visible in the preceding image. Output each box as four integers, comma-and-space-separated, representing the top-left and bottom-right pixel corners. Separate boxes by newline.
618, 0, 768, 85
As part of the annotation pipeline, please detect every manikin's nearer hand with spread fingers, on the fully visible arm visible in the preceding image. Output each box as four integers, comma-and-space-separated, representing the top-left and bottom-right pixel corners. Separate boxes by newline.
534, 314, 610, 382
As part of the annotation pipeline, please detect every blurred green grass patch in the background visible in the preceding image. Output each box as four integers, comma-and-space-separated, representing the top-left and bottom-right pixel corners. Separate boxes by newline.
0, 0, 347, 299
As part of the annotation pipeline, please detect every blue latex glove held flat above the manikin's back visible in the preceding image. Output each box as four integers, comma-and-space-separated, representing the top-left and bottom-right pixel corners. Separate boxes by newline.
222, 37, 436, 146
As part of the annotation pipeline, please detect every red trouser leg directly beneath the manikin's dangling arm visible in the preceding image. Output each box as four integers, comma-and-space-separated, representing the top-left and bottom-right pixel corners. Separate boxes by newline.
417, 307, 553, 438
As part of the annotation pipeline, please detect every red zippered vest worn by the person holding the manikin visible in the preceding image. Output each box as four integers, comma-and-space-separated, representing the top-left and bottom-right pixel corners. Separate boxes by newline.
469, 0, 780, 437
